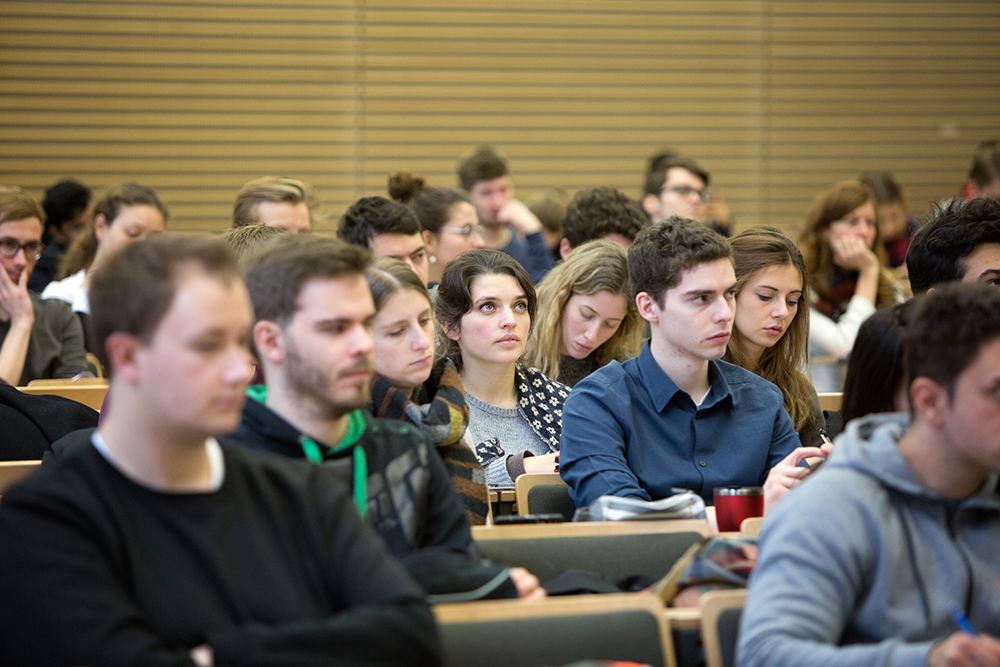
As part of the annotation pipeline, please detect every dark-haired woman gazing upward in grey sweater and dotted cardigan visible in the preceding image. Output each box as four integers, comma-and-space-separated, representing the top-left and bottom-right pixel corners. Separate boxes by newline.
436, 250, 569, 488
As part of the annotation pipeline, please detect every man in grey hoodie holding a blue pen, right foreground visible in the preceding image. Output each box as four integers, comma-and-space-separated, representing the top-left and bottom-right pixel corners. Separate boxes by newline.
736, 283, 1000, 667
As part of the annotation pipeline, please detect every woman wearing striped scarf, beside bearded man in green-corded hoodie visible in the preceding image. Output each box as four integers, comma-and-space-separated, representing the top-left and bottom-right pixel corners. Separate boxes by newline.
366, 257, 489, 525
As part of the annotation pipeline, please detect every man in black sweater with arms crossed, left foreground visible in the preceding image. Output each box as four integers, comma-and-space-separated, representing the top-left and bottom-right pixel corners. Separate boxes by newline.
0, 236, 439, 666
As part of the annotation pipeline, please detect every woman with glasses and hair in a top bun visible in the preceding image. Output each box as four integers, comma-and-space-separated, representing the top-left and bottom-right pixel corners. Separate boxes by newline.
389, 171, 485, 286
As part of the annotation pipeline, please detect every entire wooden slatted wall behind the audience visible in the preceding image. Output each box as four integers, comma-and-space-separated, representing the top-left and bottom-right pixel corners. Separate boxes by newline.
0, 0, 1000, 235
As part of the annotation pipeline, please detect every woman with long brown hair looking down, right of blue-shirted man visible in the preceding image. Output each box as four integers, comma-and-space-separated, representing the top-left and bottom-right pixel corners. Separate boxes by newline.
723, 227, 826, 447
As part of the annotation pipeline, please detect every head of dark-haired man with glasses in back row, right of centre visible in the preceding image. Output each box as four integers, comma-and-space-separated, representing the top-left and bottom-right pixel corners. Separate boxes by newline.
642, 157, 709, 225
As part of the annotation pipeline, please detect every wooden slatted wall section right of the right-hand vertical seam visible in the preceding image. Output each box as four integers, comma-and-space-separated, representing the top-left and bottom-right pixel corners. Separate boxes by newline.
761, 0, 1000, 228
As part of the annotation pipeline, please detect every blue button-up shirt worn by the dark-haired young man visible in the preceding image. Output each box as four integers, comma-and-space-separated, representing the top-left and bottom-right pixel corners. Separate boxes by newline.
559, 342, 799, 507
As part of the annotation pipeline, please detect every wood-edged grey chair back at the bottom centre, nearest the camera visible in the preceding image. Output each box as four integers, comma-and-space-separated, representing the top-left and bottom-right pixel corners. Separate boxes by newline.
434, 593, 676, 667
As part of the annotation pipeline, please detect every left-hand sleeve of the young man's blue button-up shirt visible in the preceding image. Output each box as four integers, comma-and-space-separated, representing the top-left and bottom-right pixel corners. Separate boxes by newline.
559, 379, 651, 507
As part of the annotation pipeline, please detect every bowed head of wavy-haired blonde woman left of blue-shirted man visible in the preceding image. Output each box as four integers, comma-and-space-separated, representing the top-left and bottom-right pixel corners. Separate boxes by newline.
526, 241, 643, 387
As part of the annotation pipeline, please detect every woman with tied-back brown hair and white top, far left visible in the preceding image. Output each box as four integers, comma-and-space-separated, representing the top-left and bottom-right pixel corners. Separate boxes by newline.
42, 183, 168, 313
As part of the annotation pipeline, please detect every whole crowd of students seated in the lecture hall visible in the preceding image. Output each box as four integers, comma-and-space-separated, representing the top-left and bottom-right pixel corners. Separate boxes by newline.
0, 134, 1000, 666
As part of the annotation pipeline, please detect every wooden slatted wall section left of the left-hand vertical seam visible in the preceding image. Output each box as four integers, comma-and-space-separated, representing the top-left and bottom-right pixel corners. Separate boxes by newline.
0, 0, 358, 230
